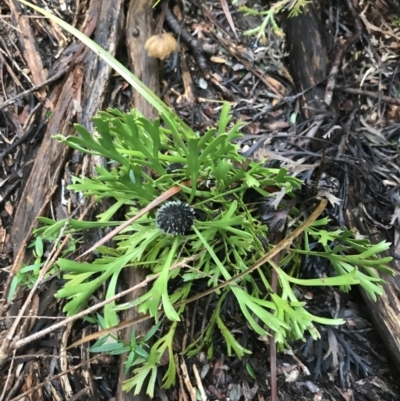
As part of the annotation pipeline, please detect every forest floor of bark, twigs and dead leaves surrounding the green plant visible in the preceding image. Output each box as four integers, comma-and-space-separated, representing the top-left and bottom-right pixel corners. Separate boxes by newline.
0, 1, 400, 401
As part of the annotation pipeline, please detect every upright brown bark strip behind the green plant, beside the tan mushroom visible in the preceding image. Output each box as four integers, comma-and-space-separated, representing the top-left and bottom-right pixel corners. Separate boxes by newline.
116, 0, 159, 401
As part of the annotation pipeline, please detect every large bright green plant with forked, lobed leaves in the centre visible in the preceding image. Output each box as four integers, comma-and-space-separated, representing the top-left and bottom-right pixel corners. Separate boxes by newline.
30, 105, 390, 395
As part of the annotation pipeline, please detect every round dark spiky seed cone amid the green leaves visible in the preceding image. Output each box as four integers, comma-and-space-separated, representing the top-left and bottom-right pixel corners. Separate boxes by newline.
156, 201, 194, 235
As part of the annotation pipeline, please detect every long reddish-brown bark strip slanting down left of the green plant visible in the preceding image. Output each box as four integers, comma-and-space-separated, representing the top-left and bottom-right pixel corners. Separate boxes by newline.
6, 0, 98, 288
